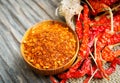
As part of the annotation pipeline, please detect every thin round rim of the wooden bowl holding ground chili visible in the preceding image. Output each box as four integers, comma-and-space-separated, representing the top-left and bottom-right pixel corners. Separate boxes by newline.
20, 20, 79, 71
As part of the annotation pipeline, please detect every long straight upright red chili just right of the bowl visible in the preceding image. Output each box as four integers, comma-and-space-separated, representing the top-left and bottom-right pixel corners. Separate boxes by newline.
79, 5, 89, 58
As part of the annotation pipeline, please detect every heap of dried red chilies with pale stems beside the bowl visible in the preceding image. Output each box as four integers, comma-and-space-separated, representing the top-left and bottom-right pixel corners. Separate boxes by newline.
50, 0, 120, 83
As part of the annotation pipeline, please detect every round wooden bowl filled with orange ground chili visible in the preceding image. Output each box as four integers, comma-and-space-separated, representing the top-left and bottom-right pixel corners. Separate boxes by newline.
20, 20, 79, 75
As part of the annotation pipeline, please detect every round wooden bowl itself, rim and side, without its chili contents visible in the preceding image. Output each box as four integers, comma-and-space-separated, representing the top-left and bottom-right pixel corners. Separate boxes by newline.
20, 20, 79, 75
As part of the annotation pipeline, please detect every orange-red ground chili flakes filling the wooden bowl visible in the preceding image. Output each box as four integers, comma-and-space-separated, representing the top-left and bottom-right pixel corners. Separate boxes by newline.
22, 22, 76, 69
